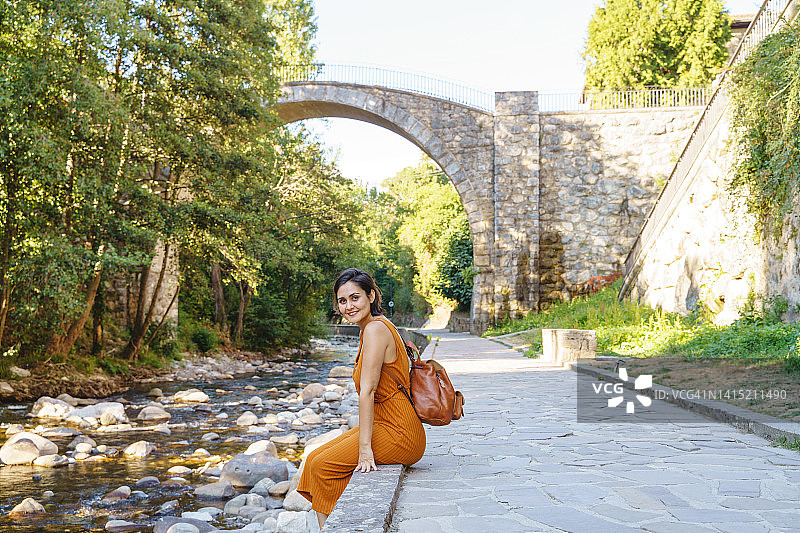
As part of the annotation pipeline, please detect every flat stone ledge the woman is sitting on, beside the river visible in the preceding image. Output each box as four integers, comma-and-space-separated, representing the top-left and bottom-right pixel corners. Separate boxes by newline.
322, 465, 405, 533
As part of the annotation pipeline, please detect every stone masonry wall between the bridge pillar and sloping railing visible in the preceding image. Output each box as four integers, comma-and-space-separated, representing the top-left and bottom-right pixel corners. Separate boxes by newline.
539, 108, 700, 303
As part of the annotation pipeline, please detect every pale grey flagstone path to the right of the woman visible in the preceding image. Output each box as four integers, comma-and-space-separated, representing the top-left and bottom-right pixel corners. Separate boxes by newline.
390, 334, 800, 533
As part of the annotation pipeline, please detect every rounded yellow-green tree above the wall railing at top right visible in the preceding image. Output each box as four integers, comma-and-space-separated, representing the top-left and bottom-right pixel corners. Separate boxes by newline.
583, 0, 731, 89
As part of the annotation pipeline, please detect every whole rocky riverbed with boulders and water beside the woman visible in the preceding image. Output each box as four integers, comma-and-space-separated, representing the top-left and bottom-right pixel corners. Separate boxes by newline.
0, 339, 357, 533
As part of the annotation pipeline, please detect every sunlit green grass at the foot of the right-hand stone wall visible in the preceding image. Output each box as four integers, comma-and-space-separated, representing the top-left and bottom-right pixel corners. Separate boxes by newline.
484, 280, 800, 366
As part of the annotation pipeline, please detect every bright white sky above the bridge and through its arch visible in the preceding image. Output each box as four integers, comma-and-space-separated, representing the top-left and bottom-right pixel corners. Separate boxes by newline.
305, 0, 761, 186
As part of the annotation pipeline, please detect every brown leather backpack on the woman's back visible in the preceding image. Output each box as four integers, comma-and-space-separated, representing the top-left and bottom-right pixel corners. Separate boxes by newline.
387, 341, 464, 426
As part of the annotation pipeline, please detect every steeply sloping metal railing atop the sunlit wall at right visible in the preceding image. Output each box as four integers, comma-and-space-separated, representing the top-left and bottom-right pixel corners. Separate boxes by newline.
619, 0, 800, 298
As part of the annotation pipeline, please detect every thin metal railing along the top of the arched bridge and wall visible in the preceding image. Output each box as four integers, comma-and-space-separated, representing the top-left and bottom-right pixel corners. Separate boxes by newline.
278, 63, 711, 113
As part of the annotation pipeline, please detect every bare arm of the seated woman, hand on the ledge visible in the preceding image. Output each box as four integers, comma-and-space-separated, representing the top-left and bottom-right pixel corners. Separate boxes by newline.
356, 320, 391, 472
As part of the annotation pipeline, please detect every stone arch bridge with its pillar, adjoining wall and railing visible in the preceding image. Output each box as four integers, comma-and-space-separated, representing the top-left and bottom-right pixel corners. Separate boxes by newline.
278, 65, 704, 333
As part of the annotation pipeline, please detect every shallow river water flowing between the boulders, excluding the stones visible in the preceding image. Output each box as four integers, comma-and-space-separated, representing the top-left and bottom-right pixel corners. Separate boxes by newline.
0, 338, 356, 533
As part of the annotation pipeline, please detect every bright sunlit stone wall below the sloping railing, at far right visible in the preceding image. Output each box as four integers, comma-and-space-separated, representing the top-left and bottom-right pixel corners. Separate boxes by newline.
626, 110, 800, 325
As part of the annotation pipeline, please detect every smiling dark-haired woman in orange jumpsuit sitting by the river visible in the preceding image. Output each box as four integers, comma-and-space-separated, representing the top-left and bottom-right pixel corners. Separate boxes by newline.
297, 268, 425, 527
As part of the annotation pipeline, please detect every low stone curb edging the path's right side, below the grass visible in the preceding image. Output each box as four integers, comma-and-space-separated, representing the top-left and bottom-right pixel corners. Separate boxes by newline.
568, 363, 800, 441
